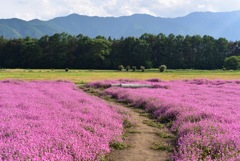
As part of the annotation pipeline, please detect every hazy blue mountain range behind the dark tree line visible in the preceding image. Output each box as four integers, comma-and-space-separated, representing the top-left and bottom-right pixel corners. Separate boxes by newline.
0, 11, 240, 41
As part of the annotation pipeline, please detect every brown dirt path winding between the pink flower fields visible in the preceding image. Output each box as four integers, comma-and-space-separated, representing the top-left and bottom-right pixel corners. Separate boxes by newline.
79, 89, 174, 161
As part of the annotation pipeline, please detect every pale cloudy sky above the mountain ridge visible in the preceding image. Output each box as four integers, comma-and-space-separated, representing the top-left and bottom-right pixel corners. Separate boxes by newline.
0, 0, 240, 20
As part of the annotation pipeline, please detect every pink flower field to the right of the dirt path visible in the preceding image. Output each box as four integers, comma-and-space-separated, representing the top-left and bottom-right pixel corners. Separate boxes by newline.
88, 79, 240, 161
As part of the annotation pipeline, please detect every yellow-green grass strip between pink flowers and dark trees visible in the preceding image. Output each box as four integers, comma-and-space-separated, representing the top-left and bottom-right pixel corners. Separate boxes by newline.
0, 69, 240, 83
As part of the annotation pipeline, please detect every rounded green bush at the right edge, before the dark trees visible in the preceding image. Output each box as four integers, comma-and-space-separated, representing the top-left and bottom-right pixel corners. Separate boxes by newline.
224, 56, 240, 70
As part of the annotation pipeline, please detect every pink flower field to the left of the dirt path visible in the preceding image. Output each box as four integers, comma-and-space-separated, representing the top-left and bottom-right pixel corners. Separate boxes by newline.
0, 81, 124, 161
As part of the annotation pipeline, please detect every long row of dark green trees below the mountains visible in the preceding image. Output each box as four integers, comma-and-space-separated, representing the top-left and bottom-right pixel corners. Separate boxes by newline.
0, 33, 240, 69
